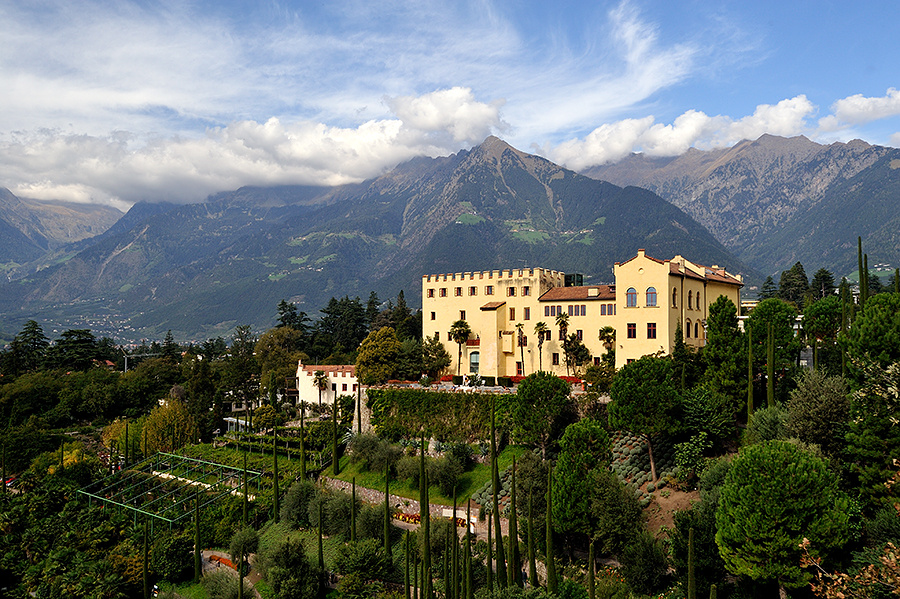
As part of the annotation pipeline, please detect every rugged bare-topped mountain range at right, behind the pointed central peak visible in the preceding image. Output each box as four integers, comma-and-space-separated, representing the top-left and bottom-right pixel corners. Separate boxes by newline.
583, 135, 900, 281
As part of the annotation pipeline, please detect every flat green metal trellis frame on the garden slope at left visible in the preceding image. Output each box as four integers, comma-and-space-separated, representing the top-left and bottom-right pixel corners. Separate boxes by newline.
78, 453, 263, 526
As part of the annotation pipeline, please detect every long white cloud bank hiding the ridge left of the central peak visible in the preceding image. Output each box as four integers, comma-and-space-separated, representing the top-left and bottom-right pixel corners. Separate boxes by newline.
0, 87, 507, 206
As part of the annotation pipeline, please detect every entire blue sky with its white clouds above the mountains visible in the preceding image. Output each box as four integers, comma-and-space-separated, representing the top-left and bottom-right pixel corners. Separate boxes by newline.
0, 0, 900, 208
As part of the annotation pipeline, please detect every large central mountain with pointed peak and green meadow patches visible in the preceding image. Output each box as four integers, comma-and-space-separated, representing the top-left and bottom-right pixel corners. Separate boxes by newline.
0, 137, 744, 342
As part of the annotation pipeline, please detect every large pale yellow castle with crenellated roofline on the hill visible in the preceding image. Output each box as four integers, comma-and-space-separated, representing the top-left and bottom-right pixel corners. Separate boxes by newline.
422, 250, 743, 377
